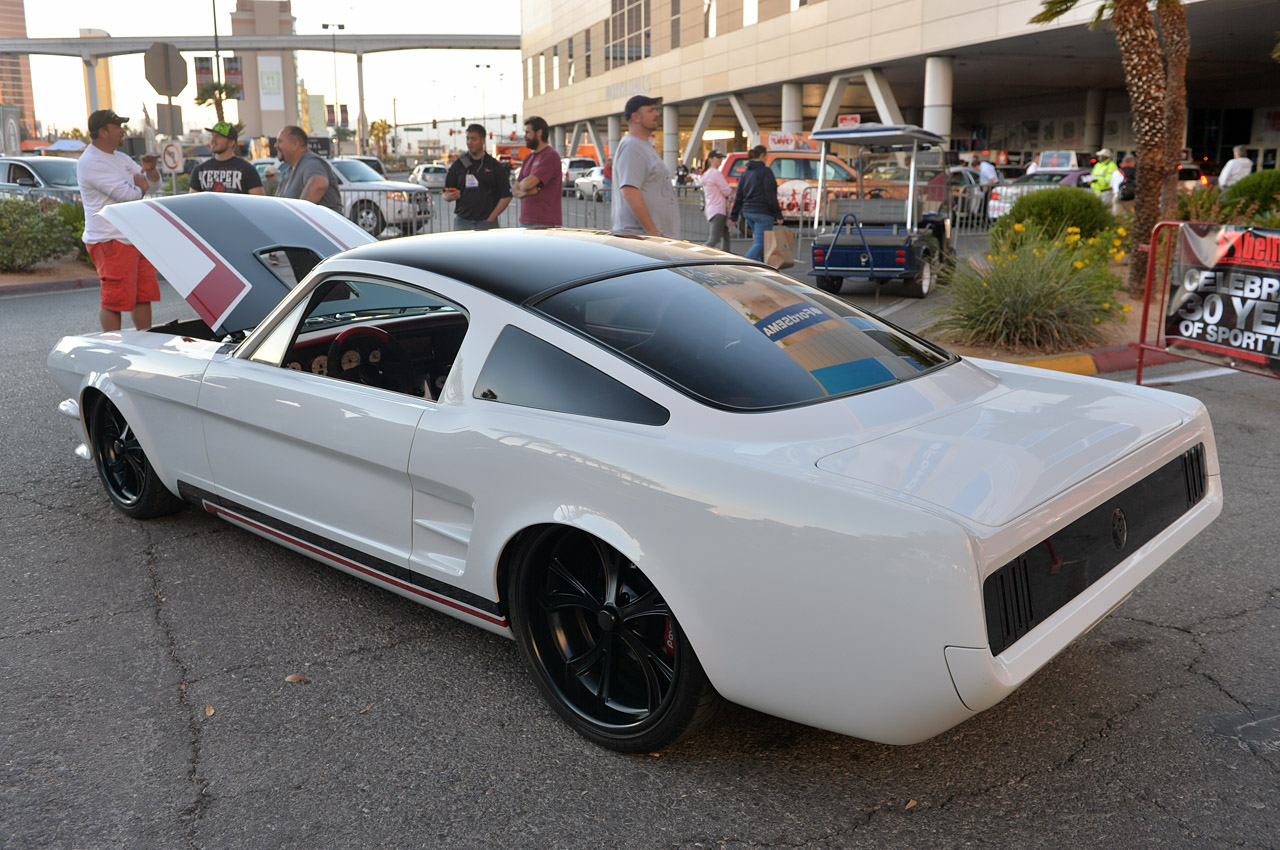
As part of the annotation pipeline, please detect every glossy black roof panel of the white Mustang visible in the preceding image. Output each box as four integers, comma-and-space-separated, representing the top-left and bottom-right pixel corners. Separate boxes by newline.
342, 228, 758, 303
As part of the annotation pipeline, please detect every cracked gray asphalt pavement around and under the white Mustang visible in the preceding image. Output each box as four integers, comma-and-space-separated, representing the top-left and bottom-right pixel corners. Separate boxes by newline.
0, 289, 1280, 850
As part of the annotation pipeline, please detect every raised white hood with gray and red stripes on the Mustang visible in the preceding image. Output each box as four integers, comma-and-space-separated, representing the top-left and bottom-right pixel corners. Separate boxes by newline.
99, 192, 374, 334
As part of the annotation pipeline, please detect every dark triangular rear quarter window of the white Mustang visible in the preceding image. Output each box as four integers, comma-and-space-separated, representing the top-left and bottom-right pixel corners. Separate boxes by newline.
474, 325, 671, 425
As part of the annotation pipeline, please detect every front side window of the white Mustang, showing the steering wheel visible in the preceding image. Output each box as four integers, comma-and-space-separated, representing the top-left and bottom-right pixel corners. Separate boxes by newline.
270, 278, 467, 399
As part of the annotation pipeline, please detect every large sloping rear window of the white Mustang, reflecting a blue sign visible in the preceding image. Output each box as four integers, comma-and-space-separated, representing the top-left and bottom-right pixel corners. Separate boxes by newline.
536, 265, 955, 410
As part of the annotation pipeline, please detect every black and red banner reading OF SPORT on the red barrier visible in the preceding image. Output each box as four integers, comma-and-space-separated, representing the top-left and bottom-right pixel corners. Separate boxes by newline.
1165, 223, 1280, 376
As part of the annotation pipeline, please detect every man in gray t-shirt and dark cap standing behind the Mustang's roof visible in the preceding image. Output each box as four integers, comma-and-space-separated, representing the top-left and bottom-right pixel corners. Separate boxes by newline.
613, 95, 680, 238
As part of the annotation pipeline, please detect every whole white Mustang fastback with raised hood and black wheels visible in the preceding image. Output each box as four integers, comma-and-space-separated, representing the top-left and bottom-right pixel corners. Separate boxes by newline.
49, 193, 1222, 751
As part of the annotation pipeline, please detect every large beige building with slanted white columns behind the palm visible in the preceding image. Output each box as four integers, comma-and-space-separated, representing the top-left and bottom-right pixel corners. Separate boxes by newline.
521, 0, 1280, 168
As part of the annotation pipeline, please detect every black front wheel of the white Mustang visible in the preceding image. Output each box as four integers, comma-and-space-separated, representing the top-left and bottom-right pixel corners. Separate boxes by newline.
88, 398, 183, 520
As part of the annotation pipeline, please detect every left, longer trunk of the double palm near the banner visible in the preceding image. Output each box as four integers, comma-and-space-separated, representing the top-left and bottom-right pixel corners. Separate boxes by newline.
1111, 0, 1166, 294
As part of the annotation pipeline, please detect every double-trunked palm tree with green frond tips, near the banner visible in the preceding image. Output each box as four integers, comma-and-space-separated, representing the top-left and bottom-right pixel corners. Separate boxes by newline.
1030, 0, 1190, 293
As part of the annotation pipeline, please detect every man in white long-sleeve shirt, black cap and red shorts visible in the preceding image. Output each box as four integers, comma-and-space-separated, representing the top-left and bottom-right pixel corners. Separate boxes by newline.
76, 109, 160, 330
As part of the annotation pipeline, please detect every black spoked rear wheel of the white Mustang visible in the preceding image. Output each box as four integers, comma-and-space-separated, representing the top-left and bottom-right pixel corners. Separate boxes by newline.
507, 529, 723, 753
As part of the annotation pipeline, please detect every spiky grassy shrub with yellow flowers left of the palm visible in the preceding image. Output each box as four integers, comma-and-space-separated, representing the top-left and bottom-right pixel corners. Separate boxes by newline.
932, 225, 1125, 353
